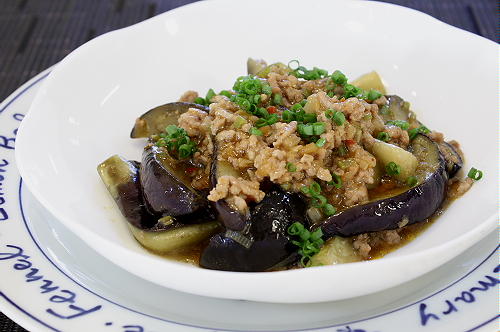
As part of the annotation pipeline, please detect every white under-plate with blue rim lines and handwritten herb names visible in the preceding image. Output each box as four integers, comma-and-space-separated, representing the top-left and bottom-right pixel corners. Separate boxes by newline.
0, 68, 499, 332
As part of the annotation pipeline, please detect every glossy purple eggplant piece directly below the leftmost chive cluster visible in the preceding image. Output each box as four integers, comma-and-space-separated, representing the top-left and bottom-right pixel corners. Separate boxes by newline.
140, 145, 209, 217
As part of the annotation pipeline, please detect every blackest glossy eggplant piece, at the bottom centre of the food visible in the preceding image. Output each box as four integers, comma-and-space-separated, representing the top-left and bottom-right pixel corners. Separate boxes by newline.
200, 186, 306, 272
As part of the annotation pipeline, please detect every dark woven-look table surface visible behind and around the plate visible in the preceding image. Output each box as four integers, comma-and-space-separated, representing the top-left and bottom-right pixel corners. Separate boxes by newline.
0, 0, 499, 332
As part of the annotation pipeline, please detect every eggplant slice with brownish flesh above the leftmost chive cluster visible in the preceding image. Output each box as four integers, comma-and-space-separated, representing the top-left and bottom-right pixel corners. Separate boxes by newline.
130, 102, 209, 138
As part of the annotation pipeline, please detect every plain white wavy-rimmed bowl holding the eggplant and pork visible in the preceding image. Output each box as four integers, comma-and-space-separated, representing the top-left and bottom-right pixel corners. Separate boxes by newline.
16, 0, 498, 303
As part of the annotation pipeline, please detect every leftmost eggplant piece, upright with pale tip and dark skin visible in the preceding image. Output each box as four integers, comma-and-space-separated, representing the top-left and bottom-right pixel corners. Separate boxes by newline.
97, 155, 156, 228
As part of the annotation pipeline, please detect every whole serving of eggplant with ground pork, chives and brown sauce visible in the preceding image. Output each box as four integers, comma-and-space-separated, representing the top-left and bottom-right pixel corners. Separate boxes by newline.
97, 59, 482, 272
